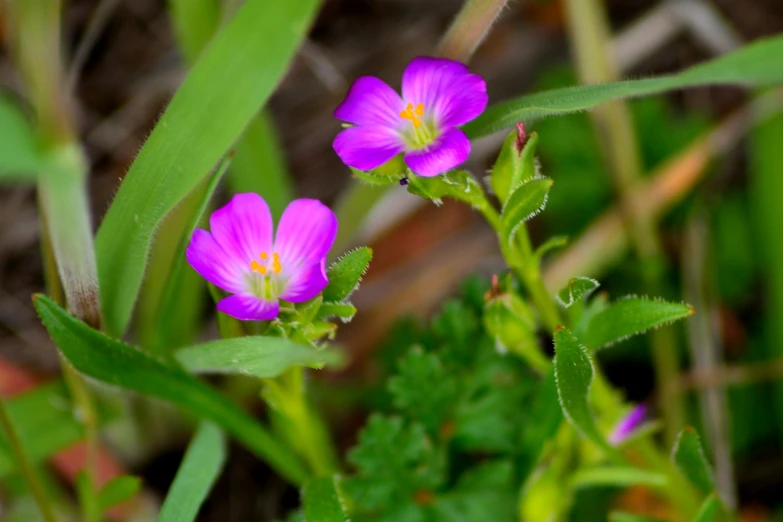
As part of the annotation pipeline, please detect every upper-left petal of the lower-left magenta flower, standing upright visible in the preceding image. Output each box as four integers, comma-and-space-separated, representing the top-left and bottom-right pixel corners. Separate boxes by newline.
209, 192, 273, 267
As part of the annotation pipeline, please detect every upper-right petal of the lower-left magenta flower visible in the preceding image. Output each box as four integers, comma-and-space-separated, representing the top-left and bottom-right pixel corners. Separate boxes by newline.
274, 199, 337, 266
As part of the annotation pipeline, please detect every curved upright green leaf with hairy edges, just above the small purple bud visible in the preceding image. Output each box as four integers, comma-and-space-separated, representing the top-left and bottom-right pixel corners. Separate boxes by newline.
555, 328, 612, 451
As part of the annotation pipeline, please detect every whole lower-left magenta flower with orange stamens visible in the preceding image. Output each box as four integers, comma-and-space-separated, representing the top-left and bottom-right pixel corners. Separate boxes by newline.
186, 193, 337, 321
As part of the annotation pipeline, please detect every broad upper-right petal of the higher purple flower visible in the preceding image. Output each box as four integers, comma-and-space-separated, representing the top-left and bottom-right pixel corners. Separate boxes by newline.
402, 57, 489, 128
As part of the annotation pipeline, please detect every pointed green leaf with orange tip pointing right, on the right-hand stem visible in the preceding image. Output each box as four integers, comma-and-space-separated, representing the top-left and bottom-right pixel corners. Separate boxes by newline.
585, 297, 694, 350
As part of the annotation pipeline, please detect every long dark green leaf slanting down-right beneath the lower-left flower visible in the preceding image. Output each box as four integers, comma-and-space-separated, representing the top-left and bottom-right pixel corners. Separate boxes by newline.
34, 294, 307, 483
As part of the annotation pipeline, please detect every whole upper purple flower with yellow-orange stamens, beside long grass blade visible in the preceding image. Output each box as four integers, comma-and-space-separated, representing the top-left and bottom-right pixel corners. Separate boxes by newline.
333, 57, 488, 176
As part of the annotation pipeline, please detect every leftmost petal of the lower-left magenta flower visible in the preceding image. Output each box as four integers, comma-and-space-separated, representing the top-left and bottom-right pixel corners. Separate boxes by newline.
185, 228, 245, 293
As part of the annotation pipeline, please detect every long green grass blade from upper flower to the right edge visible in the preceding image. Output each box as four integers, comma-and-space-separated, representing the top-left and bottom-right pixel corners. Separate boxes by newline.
463, 36, 783, 138
